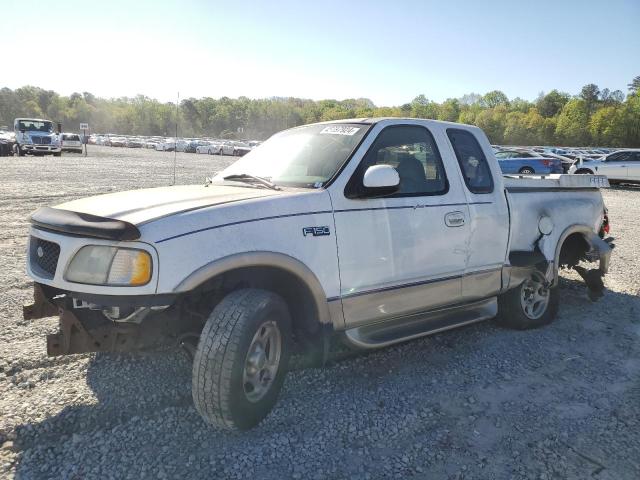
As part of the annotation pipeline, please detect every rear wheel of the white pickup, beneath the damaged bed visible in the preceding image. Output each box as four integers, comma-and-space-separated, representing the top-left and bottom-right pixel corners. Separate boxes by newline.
497, 270, 559, 330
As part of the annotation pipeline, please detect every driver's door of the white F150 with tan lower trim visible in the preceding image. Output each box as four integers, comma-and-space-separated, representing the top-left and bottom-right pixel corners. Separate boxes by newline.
331, 124, 469, 328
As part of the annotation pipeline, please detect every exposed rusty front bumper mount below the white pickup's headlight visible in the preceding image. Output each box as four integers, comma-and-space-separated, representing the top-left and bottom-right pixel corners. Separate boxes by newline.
23, 283, 175, 356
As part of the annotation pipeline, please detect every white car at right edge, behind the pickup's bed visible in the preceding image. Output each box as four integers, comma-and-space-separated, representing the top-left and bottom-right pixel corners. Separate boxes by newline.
569, 149, 640, 184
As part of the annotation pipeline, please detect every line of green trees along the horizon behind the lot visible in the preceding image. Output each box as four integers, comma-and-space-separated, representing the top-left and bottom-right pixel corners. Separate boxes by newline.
0, 76, 640, 147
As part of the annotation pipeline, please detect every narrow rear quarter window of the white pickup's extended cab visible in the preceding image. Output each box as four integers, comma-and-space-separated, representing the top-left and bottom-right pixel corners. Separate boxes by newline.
447, 128, 493, 193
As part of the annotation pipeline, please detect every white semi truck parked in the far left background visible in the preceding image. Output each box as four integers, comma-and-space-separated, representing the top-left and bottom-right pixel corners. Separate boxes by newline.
13, 118, 62, 157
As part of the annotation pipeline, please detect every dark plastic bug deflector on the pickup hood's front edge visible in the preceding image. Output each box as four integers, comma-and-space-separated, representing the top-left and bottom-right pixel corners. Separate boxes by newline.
30, 207, 140, 241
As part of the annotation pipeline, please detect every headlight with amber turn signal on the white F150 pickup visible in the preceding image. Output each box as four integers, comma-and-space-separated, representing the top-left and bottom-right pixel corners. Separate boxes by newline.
65, 245, 152, 287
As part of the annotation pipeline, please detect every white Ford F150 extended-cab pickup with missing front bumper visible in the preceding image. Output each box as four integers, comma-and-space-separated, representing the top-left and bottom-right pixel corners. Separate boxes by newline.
24, 118, 611, 429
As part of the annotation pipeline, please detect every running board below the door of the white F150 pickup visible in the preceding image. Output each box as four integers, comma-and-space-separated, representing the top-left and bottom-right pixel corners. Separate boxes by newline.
345, 297, 498, 349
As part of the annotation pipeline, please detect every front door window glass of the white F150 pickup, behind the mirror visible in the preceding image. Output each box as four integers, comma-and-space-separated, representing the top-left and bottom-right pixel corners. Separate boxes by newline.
354, 126, 449, 197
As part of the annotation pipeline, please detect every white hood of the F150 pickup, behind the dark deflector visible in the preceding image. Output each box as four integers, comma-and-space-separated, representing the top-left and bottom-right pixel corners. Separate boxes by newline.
55, 185, 283, 225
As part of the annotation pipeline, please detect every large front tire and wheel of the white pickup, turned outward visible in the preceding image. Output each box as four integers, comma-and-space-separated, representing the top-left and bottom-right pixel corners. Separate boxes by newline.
192, 289, 291, 430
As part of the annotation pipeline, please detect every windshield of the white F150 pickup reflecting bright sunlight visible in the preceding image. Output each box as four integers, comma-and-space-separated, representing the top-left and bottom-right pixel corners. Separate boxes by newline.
213, 123, 370, 188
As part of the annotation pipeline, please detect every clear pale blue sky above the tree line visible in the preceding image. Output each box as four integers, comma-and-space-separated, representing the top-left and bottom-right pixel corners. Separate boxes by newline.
0, 0, 640, 106
